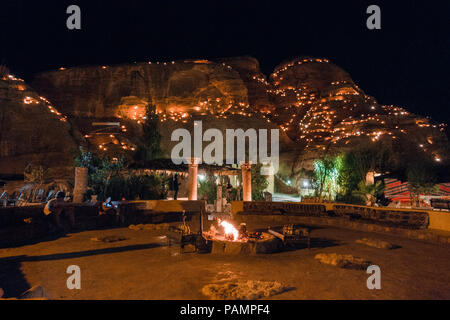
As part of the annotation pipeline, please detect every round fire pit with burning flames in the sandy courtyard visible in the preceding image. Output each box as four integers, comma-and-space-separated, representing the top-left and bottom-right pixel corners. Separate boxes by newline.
203, 219, 283, 254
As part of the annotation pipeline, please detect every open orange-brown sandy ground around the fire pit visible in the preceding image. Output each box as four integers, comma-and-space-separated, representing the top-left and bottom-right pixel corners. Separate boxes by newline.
0, 222, 450, 299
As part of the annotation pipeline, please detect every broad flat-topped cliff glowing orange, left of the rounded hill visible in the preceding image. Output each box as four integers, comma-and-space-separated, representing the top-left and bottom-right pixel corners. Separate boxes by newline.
33, 57, 295, 170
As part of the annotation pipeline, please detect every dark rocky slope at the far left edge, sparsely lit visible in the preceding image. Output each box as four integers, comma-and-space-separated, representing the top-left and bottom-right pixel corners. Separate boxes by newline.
0, 74, 77, 178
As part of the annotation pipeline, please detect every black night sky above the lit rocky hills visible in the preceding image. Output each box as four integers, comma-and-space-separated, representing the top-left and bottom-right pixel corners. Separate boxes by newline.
0, 0, 450, 123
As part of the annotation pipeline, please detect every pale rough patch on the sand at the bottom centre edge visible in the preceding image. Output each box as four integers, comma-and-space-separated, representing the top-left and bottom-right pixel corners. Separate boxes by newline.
202, 280, 289, 300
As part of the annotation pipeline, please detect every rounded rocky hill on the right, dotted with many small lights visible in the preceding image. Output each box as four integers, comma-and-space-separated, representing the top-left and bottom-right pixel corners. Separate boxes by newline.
267, 58, 448, 169
